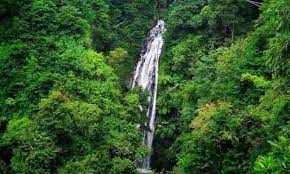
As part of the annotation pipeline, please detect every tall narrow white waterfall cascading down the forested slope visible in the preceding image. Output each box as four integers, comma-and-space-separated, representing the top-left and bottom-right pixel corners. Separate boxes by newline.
132, 20, 165, 173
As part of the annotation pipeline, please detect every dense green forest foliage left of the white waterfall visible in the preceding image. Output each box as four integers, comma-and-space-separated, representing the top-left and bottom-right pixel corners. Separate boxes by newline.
0, 0, 154, 174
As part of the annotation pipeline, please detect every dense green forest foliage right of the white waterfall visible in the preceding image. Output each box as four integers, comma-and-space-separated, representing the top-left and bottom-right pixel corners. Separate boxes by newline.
153, 0, 290, 174
